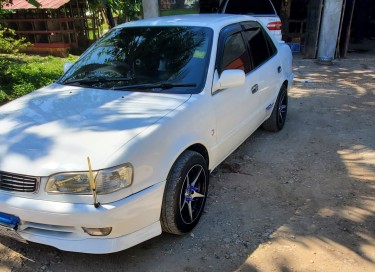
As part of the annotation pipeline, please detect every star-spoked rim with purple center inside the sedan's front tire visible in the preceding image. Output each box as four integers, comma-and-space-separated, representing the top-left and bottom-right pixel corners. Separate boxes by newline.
180, 164, 207, 224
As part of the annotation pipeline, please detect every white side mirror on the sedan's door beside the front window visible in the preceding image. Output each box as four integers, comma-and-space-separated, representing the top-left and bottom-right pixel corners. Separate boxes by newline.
212, 69, 246, 93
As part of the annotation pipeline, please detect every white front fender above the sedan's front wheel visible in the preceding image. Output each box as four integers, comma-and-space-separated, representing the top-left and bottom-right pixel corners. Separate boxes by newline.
103, 94, 216, 196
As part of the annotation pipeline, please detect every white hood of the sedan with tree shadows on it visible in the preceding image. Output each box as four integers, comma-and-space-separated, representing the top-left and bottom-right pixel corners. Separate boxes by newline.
0, 84, 190, 176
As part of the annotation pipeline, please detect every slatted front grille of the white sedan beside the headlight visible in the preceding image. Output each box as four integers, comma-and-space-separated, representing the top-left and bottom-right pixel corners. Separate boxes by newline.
0, 171, 38, 193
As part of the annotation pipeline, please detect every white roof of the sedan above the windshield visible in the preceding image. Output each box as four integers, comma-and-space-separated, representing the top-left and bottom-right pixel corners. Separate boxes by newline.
118, 14, 258, 30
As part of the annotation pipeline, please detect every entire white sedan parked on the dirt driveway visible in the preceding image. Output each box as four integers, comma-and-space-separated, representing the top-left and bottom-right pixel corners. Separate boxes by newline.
0, 14, 293, 253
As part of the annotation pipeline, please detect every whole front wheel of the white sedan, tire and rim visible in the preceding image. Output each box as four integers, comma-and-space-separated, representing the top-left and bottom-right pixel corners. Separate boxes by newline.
160, 150, 209, 235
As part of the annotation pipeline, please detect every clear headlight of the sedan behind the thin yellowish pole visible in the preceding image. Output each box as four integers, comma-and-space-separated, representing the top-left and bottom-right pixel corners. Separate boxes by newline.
46, 163, 133, 195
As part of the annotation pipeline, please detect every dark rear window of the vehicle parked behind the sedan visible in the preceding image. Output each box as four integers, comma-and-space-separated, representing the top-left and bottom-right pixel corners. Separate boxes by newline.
224, 0, 275, 15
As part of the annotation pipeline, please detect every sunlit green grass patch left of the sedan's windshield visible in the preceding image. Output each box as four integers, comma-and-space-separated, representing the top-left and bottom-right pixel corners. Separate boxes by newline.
0, 54, 78, 105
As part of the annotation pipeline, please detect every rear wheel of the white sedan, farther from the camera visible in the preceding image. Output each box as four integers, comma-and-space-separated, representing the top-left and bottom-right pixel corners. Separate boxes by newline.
262, 85, 288, 132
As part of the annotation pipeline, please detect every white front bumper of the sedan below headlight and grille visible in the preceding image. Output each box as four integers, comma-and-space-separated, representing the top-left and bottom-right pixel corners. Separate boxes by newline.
0, 182, 164, 254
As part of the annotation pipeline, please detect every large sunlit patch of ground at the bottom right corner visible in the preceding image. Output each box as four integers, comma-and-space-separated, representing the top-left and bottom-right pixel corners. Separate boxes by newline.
238, 236, 375, 272
